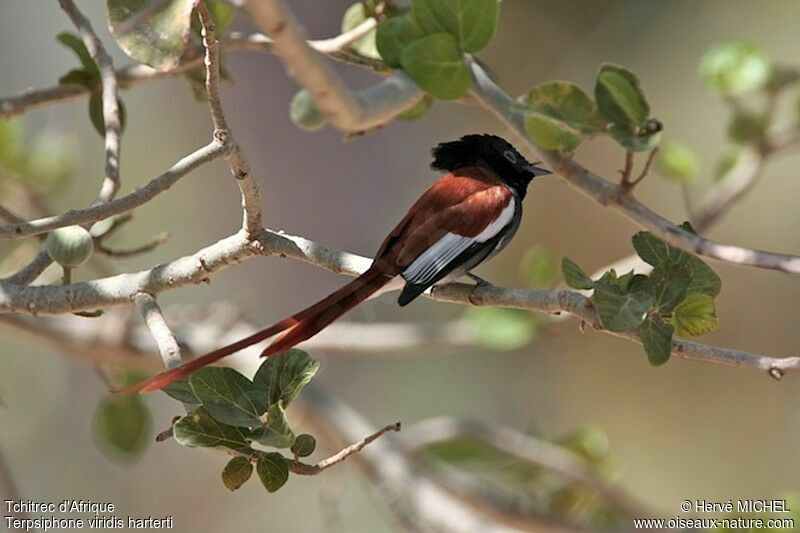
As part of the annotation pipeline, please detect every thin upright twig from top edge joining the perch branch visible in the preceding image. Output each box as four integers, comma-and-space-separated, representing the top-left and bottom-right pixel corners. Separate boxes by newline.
197, 1, 261, 239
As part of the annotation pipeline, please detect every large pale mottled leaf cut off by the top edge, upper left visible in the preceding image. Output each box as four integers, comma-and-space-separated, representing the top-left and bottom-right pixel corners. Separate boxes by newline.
108, 0, 196, 72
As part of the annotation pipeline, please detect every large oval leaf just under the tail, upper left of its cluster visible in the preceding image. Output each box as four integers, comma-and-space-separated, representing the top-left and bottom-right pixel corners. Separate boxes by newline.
189, 367, 270, 427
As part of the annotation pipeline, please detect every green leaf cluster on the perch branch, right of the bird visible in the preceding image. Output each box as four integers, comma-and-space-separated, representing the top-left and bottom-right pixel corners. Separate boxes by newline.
562, 222, 722, 366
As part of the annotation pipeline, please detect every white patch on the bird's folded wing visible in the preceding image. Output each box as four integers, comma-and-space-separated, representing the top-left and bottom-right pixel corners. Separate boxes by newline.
402, 200, 514, 285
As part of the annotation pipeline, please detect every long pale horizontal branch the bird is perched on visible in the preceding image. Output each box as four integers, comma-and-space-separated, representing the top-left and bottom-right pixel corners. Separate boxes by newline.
0, 230, 800, 378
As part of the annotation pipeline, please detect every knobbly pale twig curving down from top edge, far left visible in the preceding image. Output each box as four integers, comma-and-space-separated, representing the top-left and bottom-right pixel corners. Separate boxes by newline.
59, 0, 122, 204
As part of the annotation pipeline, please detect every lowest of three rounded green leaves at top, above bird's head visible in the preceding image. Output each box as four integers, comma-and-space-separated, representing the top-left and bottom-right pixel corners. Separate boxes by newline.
400, 33, 470, 100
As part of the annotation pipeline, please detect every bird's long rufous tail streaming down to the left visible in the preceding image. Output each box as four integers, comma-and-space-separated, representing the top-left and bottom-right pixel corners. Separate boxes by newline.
115, 268, 392, 393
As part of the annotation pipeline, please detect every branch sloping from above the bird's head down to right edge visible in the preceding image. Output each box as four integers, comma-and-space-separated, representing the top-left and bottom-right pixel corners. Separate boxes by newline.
469, 59, 800, 274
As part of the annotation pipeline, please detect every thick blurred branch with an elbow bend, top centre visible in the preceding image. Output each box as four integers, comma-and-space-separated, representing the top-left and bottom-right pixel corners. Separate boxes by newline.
247, 0, 423, 132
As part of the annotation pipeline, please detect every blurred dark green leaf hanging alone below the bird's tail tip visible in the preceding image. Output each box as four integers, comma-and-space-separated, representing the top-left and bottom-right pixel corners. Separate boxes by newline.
93, 394, 152, 459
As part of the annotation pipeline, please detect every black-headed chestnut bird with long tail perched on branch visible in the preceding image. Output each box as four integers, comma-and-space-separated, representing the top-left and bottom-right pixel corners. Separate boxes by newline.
118, 134, 551, 393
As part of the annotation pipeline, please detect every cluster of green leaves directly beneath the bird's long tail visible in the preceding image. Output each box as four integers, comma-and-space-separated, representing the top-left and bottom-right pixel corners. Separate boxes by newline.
164, 349, 319, 492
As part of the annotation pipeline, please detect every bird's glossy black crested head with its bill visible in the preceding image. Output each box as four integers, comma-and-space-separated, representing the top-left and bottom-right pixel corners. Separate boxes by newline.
431, 134, 551, 198
